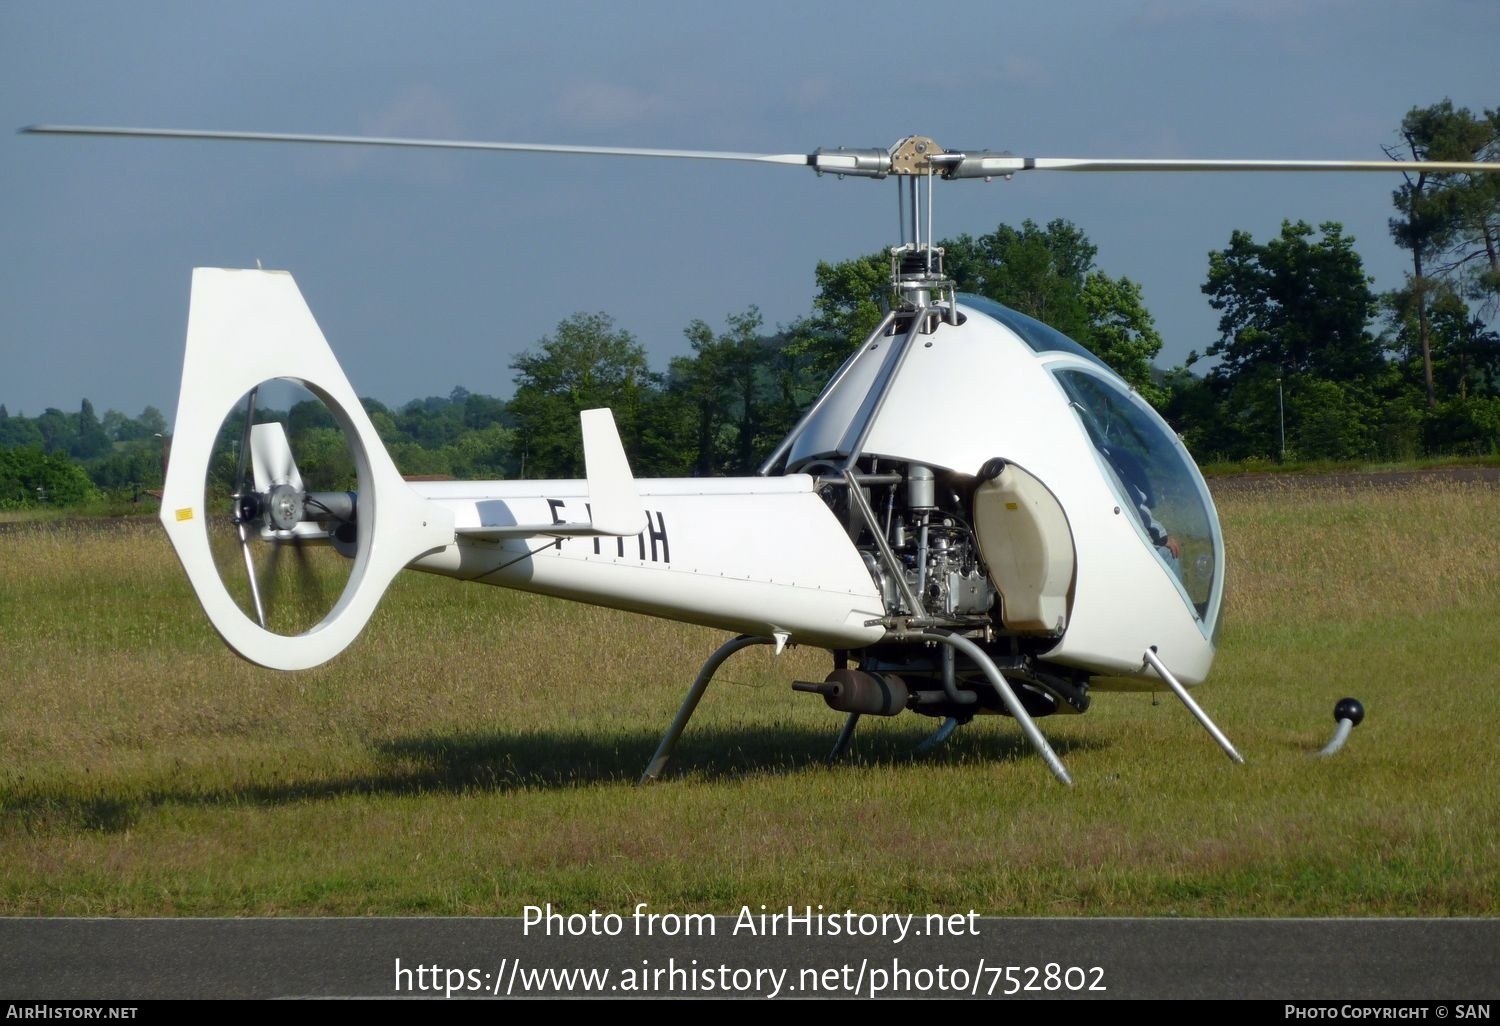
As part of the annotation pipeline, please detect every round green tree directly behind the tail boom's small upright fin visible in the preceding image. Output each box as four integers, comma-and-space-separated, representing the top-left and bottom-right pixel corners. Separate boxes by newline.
510, 314, 654, 477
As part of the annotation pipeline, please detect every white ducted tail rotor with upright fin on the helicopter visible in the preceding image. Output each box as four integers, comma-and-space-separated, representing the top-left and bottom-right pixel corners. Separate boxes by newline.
162, 269, 455, 669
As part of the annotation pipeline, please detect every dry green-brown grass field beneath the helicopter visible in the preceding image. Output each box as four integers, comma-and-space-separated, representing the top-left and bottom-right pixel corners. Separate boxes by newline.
0, 480, 1500, 917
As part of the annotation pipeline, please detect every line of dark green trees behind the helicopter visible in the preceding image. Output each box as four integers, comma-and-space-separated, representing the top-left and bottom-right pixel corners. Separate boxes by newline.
0, 101, 1500, 507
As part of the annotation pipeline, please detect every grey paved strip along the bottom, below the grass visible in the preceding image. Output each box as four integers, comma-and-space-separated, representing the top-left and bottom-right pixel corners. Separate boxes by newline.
0, 914, 1500, 1001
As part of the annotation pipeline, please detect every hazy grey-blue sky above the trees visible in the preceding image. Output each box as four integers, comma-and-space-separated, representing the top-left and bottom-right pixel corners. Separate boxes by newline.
0, 0, 1500, 417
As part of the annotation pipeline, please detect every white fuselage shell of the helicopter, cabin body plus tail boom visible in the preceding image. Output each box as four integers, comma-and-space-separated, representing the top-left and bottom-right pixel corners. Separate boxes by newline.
399, 306, 1223, 684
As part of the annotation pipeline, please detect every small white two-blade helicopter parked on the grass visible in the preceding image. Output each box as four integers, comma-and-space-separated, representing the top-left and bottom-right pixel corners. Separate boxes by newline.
24, 126, 1500, 785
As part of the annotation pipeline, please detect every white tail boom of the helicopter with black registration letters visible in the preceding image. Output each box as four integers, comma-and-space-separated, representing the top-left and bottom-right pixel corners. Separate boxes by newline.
411, 474, 885, 648
